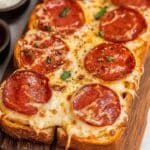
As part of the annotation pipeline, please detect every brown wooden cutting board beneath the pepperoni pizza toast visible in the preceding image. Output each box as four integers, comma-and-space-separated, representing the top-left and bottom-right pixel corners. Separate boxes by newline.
0, 0, 150, 150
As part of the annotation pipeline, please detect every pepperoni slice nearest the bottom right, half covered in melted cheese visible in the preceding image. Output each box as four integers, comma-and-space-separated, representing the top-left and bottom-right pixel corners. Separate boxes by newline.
72, 84, 121, 127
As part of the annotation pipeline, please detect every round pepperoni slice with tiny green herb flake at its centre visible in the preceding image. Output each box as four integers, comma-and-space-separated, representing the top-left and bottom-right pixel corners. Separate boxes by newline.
84, 43, 135, 81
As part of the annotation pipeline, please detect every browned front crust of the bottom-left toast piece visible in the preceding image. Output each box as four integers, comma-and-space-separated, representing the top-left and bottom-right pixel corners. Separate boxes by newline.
0, 117, 55, 144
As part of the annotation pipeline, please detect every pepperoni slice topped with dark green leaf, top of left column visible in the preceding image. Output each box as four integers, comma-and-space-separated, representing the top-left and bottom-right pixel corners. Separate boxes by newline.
37, 0, 85, 34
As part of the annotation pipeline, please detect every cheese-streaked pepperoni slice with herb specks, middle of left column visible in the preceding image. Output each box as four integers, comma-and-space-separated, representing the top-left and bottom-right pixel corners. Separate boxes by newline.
19, 31, 69, 74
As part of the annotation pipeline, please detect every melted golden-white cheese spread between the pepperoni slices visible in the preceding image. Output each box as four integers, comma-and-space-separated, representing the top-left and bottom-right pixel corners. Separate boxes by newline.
0, 0, 150, 146
